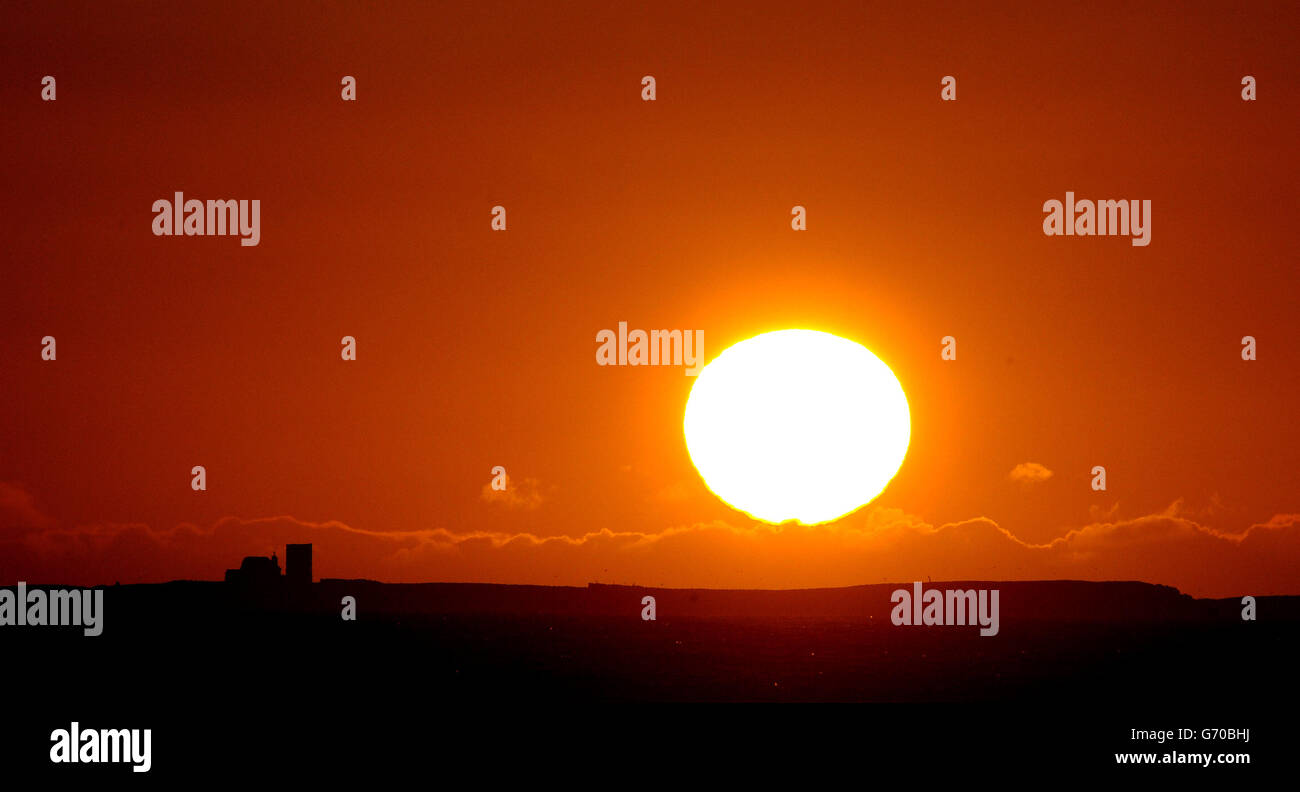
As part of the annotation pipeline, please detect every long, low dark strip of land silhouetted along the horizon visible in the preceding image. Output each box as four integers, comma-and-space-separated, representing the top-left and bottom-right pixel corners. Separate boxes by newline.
17, 577, 1300, 629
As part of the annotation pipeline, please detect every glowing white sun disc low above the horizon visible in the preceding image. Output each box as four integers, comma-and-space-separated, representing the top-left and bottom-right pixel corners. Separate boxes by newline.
683, 330, 911, 525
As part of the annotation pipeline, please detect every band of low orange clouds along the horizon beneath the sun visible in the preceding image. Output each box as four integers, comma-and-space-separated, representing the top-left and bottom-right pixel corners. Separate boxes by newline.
0, 484, 1300, 597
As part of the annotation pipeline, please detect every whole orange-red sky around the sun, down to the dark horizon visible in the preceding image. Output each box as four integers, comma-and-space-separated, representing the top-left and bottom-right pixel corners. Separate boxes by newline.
0, 3, 1300, 596
